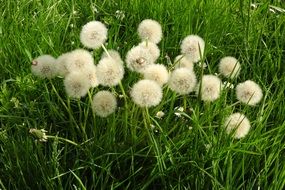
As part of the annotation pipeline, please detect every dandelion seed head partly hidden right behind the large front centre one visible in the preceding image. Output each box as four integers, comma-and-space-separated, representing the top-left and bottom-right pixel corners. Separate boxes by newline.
142, 64, 168, 86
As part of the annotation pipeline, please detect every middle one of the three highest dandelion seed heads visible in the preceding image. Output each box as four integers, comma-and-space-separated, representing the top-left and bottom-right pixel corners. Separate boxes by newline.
138, 19, 162, 44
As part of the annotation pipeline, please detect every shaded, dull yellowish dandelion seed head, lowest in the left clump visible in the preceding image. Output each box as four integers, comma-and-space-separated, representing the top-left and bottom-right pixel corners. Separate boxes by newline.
92, 90, 117, 117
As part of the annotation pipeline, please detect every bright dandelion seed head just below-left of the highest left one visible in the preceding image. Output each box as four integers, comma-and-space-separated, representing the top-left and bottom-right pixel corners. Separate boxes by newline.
65, 49, 94, 73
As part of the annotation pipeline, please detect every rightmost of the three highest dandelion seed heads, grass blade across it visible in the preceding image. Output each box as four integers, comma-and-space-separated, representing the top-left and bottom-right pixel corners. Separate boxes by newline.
181, 35, 205, 63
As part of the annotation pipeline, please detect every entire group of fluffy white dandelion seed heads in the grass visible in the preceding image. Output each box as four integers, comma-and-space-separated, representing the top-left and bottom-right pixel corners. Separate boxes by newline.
31, 19, 263, 139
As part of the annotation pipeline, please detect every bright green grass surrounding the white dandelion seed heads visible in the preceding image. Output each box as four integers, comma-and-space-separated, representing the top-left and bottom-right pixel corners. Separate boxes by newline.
0, 0, 285, 190
